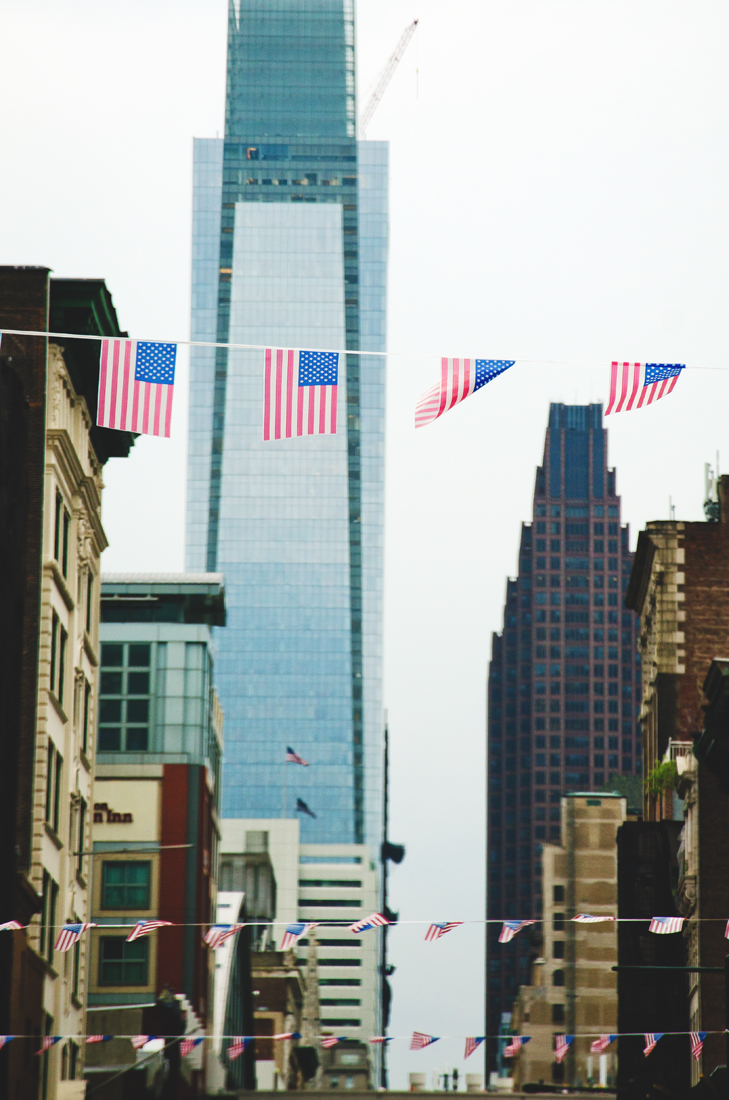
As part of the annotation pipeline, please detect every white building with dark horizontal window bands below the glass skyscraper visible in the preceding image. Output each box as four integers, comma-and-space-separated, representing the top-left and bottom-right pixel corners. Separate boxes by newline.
221, 818, 382, 1060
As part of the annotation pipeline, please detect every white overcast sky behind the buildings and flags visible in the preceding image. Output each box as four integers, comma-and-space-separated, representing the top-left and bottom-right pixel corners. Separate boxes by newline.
0, 0, 729, 1088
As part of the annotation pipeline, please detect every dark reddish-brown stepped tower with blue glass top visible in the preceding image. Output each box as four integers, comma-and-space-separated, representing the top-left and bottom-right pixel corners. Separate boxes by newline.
486, 405, 641, 1066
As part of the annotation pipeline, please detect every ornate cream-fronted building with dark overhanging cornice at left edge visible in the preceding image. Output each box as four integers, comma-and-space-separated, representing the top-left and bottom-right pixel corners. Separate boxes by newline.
0, 267, 133, 1100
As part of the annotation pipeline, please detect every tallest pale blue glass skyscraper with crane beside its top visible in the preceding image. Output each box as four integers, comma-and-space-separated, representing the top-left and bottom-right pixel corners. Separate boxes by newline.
187, 0, 388, 845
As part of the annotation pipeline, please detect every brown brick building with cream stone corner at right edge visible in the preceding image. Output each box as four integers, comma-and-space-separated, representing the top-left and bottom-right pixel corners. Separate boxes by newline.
627, 495, 729, 1084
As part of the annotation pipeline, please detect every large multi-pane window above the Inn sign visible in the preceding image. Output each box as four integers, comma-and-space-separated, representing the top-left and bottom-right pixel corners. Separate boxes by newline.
99, 642, 152, 752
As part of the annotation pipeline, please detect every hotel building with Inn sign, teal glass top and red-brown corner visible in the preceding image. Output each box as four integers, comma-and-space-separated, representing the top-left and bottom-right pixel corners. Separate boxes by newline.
83, 574, 225, 1091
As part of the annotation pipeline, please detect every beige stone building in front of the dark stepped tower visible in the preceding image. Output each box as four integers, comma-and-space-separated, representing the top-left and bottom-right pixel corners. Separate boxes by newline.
511, 793, 627, 1091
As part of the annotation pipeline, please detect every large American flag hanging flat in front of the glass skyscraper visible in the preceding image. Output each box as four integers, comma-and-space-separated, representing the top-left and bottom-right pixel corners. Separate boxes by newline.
263, 348, 339, 440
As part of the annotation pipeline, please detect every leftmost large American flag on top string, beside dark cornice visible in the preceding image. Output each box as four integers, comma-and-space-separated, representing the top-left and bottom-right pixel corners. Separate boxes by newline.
96, 340, 177, 439
